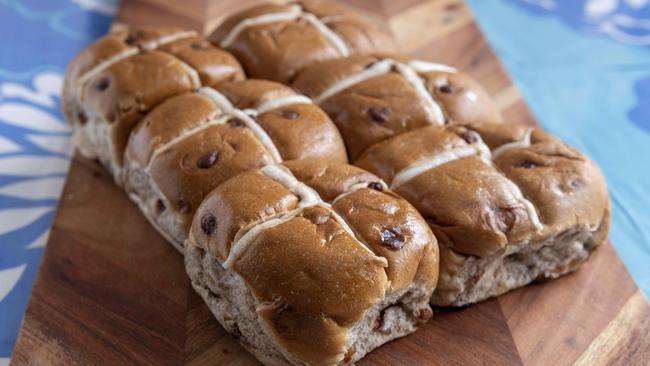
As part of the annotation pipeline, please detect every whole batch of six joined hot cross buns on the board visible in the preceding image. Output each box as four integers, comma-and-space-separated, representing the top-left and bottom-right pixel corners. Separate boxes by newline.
63, 1, 609, 365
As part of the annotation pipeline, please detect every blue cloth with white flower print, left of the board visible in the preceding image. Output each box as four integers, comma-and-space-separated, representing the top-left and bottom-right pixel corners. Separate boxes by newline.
0, 0, 117, 366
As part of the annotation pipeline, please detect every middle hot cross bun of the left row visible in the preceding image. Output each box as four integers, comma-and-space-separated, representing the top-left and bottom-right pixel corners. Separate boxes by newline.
126, 79, 347, 234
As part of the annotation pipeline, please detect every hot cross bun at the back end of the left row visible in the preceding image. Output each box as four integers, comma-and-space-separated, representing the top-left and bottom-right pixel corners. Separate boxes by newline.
63, 27, 244, 166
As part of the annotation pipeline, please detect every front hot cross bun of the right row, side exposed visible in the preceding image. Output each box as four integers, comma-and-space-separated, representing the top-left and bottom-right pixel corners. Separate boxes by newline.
355, 123, 609, 306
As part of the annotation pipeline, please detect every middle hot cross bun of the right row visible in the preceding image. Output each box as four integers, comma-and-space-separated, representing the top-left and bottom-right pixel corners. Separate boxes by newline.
292, 55, 501, 160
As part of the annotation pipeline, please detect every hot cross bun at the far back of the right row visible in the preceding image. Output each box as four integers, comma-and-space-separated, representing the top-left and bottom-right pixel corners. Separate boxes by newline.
209, 1, 394, 83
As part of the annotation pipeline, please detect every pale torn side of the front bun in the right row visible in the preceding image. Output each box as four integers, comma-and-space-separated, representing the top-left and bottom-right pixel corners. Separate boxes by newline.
431, 203, 610, 306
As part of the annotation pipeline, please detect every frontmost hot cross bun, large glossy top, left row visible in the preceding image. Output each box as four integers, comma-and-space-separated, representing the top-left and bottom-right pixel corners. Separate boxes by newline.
186, 160, 439, 365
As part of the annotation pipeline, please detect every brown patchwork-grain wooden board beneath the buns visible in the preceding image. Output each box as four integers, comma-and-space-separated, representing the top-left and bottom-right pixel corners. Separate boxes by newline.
12, 0, 650, 365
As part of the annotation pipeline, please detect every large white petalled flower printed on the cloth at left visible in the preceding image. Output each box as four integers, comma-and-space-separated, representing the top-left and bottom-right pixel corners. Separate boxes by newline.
0, 72, 70, 304
